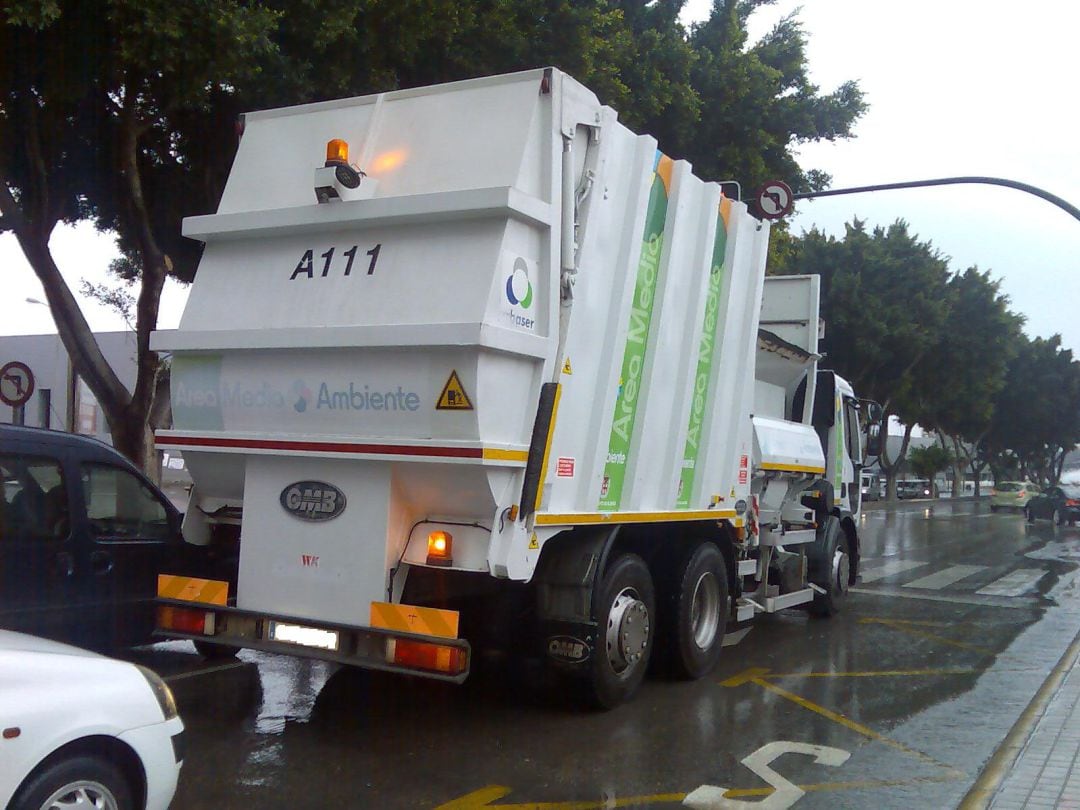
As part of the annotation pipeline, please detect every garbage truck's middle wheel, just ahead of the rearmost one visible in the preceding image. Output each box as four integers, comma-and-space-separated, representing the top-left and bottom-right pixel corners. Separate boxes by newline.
656, 542, 730, 680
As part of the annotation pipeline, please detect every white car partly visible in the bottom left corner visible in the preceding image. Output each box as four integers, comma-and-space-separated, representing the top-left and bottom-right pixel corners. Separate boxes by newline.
0, 630, 184, 810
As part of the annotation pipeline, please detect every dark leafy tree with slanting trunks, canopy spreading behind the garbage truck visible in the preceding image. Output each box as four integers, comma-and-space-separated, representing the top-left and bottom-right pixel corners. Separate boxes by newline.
0, 0, 865, 475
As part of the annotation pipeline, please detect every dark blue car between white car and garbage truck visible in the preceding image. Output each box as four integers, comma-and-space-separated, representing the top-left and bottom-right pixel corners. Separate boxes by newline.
0, 424, 195, 651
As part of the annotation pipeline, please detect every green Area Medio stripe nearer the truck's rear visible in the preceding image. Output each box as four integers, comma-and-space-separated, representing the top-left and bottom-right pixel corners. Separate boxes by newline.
598, 152, 667, 512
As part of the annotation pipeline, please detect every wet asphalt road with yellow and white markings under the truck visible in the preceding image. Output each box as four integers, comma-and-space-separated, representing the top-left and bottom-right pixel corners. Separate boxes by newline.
132, 501, 1080, 810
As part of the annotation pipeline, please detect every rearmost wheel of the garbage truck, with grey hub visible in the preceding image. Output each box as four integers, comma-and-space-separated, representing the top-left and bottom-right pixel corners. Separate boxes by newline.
586, 554, 657, 708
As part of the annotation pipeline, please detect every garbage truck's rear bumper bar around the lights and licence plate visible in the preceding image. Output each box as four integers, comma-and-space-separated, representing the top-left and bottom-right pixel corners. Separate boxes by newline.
154, 598, 472, 684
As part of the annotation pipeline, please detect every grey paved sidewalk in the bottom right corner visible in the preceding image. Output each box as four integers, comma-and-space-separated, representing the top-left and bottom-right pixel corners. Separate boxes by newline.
978, 636, 1080, 810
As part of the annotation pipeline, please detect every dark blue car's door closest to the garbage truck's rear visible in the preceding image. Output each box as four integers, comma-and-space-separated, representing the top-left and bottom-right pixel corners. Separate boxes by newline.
80, 461, 179, 645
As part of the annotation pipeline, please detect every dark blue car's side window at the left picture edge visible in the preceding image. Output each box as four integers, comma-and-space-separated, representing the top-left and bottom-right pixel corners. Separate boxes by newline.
0, 454, 71, 542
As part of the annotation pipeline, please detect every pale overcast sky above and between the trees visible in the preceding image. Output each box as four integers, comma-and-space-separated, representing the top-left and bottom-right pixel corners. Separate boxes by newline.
0, 0, 1080, 355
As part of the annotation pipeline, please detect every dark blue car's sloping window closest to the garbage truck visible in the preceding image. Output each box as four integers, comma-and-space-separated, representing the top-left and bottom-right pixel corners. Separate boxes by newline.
82, 463, 171, 540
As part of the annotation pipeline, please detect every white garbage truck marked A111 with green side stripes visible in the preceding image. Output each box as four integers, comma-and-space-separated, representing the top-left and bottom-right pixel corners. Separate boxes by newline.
153, 69, 866, 706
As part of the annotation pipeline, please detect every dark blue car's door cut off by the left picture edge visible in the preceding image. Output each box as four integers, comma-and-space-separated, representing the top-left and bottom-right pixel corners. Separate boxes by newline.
0, 447, 87, 644
